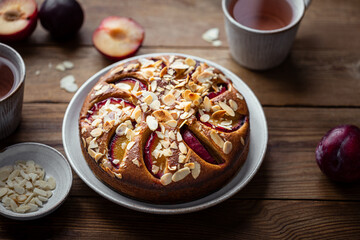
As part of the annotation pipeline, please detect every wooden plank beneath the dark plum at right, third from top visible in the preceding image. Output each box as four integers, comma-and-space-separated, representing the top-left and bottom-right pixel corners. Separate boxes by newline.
0, 103, 360, 200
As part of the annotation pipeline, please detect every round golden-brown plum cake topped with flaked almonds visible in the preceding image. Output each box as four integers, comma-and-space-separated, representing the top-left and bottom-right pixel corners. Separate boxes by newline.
79, 56, 250, 203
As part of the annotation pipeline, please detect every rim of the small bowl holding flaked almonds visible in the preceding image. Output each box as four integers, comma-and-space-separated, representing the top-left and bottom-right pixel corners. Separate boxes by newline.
0, 142, 73, 220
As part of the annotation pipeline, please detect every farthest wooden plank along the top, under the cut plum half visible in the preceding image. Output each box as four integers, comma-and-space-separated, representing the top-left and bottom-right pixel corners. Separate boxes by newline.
20, 0, 360, 50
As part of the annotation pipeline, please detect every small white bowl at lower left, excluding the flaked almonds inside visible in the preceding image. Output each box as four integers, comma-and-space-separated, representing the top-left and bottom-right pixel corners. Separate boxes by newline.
0, 142, 73, 220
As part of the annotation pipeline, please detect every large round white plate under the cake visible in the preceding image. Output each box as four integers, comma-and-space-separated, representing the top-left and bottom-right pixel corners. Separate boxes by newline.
62, 53, 268, 214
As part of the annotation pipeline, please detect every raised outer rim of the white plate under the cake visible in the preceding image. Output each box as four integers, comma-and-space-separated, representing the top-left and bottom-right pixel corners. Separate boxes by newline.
62, 53, 268, 214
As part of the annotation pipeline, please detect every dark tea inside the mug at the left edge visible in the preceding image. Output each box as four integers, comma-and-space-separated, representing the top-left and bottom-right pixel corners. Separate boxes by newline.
0, 57, 16, 100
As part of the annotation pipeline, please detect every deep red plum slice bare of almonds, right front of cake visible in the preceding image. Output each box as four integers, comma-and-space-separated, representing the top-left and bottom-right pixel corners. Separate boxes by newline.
181, 128, 219, 164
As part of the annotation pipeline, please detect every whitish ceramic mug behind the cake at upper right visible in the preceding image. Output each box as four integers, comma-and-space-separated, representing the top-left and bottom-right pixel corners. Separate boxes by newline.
222, 0, 311, 70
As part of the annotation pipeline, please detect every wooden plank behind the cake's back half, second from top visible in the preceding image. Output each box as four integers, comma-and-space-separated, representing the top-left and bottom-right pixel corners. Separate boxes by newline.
10, 47, 360, 106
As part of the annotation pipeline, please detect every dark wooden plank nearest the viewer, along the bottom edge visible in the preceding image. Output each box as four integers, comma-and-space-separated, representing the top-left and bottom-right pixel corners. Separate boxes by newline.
0, 197, 360, 239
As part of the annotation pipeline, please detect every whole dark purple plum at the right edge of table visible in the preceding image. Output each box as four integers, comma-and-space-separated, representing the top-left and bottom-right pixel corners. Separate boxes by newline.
316, 125, 360, 182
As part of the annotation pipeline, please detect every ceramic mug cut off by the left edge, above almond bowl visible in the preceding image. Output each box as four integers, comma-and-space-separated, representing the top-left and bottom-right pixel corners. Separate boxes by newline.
0, 43, 25, 139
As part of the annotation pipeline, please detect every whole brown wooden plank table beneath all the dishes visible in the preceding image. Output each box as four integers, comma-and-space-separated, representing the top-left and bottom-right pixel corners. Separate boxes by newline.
0, 0, 360, 239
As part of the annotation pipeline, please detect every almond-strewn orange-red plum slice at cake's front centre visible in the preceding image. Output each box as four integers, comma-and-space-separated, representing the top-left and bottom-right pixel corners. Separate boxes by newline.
144, 132, 166, 178
